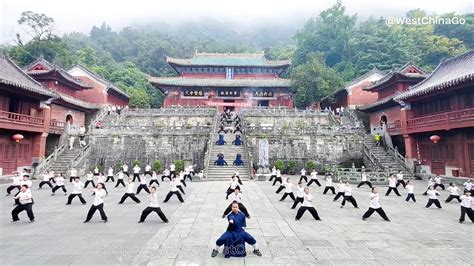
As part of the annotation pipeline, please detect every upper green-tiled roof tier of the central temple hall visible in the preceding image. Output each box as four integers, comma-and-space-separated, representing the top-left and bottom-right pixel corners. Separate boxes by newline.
166, 52, 291, 67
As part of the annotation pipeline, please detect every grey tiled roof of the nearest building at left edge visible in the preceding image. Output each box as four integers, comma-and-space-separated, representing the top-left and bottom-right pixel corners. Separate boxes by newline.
0, 55, 57, 98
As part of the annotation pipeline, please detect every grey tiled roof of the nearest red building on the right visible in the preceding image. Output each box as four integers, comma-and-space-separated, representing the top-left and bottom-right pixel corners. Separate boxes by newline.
394, 50, 474, 101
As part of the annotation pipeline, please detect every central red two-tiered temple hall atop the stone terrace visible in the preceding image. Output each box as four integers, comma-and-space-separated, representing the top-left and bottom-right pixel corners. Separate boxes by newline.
149, 52, 293, 111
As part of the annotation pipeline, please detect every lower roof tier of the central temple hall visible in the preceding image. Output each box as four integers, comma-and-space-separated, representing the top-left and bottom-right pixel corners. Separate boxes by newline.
148, 77, 290, 87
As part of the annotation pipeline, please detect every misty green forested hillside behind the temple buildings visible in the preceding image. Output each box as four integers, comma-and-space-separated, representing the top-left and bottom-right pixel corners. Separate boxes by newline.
0, 1, 474, 108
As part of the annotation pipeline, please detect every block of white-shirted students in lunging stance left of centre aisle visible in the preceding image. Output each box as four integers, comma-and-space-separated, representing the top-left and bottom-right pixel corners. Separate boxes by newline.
7, 163, 194, 223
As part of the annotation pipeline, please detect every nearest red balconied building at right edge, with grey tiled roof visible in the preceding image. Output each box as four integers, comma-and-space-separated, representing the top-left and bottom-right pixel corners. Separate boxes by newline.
389, 50, 474, 177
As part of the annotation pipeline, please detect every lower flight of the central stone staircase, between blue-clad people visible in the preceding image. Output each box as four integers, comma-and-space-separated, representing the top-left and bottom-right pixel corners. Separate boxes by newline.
207, 133, 250, 180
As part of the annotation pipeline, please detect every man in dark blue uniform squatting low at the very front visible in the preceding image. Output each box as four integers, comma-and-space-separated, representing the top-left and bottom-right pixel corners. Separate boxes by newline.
211, 201, 262, 258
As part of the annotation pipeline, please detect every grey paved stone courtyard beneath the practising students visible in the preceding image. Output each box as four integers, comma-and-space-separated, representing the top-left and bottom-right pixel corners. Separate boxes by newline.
0, 177, 474, 265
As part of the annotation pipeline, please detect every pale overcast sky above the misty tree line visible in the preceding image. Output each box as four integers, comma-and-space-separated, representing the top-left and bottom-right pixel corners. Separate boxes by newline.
0, 0, 474, 43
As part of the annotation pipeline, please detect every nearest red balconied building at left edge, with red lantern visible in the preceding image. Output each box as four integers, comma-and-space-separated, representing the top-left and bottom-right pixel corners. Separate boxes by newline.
0, 56, 58, 175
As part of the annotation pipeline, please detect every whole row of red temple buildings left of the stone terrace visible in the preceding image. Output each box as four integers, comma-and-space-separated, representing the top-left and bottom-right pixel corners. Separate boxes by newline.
0, 56, 129, 176
